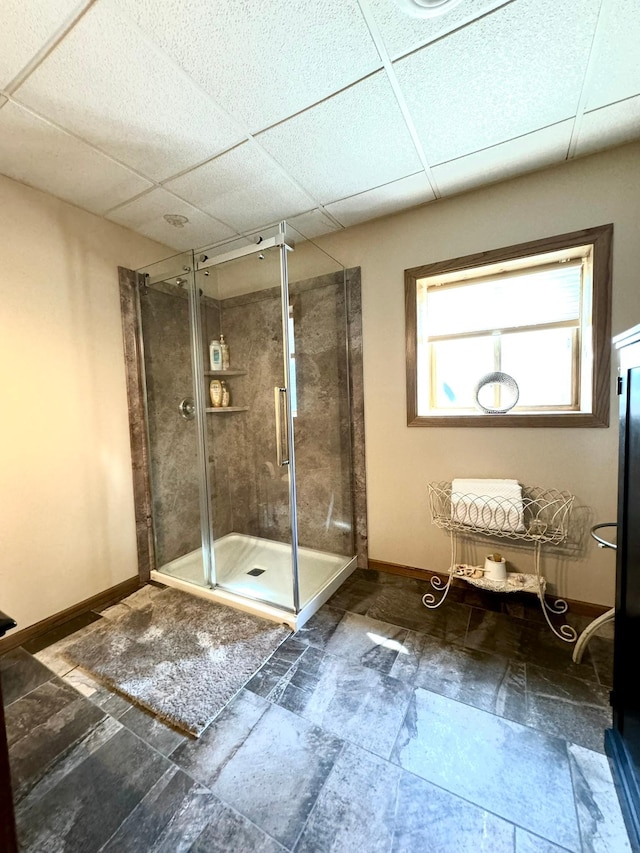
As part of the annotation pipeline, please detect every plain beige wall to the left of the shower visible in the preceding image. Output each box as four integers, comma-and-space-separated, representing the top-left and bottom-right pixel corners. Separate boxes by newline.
0, 176, 171, 628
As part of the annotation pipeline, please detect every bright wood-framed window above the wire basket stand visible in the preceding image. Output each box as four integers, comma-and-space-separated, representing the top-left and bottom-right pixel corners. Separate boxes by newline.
405, 225, 613, 426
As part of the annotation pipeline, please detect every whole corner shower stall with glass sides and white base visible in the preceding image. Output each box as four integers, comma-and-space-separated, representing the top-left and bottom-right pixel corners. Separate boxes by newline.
123, 222, 366, 628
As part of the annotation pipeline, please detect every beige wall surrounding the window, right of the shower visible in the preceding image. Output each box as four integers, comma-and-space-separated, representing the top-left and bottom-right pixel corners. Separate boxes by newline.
319, 145, 640, 605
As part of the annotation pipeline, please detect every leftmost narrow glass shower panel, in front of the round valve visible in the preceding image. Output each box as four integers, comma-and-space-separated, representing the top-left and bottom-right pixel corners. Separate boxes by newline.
138, 253, 212, 586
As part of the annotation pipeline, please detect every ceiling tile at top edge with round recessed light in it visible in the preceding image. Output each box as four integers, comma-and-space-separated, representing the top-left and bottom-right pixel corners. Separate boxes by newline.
362, 0, 509, 59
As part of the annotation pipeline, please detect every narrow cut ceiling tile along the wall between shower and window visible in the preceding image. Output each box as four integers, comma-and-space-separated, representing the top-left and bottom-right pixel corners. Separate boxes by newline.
327, 172, 434, 227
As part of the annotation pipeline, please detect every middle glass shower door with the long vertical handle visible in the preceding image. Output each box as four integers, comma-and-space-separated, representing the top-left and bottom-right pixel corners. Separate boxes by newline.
196, 245, 294, 610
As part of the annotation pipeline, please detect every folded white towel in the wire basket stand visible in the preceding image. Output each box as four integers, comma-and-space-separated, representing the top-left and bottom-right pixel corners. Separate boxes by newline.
451, 479, 524, 533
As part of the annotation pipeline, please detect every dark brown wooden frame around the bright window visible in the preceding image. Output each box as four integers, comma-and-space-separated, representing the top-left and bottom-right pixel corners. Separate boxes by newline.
404, 224, 613, 427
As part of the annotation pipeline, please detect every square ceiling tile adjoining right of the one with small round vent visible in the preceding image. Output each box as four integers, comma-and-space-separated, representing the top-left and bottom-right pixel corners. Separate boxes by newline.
166, 142, 314, 231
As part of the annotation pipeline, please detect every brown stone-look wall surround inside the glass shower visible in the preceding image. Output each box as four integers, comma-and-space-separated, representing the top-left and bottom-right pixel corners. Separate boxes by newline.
141, 270, 366, 565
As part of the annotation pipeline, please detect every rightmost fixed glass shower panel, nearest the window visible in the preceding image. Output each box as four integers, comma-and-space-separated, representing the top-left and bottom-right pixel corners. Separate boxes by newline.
286, 226, 355, 608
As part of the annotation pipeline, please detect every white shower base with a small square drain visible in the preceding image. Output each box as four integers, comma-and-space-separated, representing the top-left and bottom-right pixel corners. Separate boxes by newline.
151, 533, 356, 631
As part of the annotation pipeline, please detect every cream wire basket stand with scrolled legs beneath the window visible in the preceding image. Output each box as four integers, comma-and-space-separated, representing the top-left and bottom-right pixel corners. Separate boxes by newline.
422, 482, 577, 643
